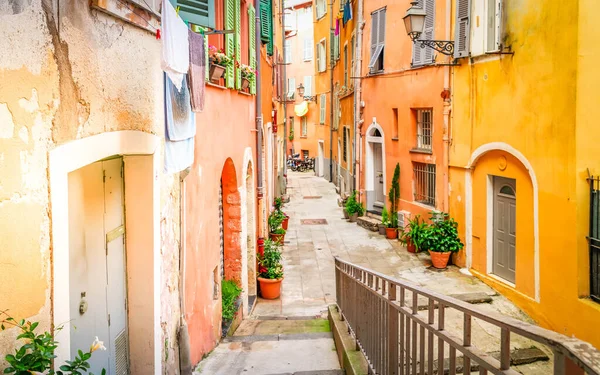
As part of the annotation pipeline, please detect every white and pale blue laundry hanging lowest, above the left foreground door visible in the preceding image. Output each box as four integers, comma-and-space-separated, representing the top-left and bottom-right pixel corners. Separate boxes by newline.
164, 75, 196, 173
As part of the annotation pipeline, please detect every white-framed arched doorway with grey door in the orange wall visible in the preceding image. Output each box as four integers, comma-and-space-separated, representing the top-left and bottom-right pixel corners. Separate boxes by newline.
365, 123, 386, 213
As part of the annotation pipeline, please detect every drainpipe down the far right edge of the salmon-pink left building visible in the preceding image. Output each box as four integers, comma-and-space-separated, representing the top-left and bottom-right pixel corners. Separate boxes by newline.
254, 0, 264, 240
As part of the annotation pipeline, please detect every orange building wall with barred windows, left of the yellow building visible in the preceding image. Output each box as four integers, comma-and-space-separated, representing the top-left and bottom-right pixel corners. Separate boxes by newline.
360, 0, 448, 217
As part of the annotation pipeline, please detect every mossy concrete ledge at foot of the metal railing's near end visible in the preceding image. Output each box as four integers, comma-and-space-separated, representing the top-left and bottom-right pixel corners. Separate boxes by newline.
328, 305, 368, 375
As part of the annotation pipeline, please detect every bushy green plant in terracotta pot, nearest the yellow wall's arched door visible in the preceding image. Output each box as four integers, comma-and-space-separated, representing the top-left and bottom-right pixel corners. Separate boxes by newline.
423, 212, 464, 269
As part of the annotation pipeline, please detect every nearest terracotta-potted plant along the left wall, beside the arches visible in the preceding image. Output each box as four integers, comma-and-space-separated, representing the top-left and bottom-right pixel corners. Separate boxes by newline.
258, 240, 283, 299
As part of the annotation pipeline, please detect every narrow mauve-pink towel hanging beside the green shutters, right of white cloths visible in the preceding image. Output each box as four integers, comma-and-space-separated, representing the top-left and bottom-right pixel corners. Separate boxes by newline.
188, 30, 206, 112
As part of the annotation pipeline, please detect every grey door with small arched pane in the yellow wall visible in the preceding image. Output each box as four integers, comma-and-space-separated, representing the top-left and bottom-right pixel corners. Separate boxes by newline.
493, 177, 517, 283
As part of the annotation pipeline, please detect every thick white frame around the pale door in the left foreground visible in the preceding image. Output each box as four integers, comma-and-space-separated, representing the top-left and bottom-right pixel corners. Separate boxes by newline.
49, 130, 162, 375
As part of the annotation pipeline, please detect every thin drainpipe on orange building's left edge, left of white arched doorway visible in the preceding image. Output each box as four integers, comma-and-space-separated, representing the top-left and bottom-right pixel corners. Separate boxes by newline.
354, 0, 365, 197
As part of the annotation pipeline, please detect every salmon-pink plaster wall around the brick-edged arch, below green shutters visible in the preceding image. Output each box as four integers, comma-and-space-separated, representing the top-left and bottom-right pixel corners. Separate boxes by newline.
185, 86, 258, 364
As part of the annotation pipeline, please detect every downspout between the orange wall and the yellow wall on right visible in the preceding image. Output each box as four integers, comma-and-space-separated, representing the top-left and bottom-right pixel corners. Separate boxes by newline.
442, 0, 452, 212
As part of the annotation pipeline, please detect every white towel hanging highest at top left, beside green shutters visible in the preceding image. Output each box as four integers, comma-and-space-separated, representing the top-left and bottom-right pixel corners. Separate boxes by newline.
160, 0, 190, 89
